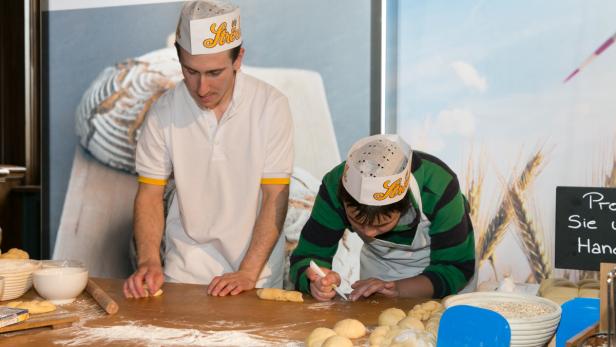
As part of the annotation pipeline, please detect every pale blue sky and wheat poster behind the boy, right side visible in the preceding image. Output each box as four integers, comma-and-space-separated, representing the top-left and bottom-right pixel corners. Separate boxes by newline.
395, 0, 616, 282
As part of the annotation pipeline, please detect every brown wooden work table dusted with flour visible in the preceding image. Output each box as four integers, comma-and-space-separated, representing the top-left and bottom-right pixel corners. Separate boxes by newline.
0, 279, 424, 347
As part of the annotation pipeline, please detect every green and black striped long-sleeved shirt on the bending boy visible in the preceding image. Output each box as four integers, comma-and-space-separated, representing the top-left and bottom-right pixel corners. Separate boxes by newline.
290, 151, 475, 298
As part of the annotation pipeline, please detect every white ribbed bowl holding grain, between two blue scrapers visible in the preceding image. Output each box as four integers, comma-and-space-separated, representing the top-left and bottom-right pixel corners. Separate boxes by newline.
444, 292, 562, 347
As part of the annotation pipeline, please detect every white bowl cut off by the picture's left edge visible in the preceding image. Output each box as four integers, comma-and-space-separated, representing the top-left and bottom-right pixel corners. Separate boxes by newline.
0, 259, 41, 301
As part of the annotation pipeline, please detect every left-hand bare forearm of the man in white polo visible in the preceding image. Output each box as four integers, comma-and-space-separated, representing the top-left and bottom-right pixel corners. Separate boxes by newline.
134, 188, 164, 265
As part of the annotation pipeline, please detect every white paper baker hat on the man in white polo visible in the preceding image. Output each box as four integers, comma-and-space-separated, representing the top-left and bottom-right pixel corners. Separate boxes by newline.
175, 0, 242, 55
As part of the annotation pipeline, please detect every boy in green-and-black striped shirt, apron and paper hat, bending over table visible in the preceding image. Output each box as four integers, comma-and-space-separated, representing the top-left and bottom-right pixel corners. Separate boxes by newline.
290, 135, 475, 301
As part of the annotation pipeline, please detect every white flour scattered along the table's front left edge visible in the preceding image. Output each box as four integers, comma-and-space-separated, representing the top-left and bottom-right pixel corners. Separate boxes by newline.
56, 322, 299, 347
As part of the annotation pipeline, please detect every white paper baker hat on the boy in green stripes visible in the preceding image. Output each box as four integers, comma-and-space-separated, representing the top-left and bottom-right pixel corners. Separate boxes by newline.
342, 134, 412, 206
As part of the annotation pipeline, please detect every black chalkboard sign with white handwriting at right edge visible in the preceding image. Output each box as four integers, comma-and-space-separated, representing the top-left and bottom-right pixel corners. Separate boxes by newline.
554, 187, 616, 271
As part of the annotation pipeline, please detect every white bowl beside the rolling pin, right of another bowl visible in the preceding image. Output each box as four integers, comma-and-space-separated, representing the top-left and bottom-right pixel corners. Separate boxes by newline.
33, 267, 88, 305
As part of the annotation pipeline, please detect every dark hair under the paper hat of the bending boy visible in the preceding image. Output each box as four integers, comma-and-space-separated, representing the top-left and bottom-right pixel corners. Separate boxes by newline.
338, 181, 411, 224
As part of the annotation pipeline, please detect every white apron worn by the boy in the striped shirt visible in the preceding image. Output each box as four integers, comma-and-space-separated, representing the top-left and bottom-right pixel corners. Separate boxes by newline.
357, 174, 430, 281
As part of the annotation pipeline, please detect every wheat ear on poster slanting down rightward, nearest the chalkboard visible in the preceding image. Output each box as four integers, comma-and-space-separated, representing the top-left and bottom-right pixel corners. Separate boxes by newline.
508, 187, 552, 283
